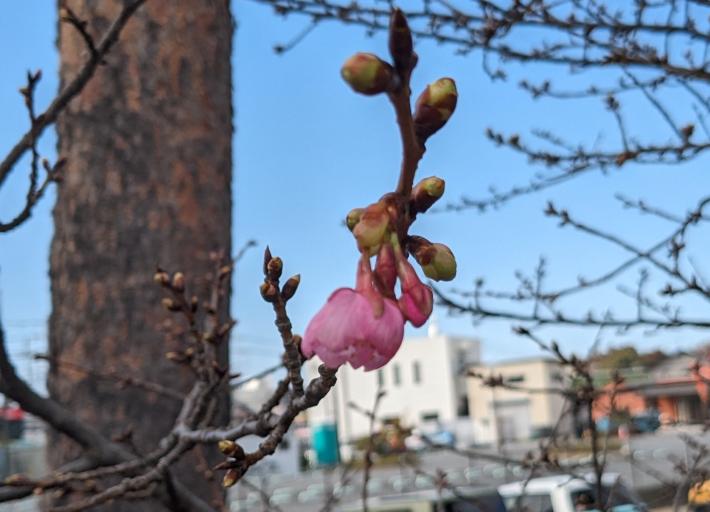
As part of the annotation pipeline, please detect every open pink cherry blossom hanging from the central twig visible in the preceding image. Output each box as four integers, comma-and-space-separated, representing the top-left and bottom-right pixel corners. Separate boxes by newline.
301, 257, 404, 371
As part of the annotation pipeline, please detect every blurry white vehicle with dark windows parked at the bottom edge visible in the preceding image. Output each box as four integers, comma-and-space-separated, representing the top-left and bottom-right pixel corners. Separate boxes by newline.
498, 473, 646, 512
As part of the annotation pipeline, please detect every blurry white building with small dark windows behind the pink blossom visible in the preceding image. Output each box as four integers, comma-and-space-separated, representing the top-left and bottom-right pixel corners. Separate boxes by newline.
306, 324, 480, 452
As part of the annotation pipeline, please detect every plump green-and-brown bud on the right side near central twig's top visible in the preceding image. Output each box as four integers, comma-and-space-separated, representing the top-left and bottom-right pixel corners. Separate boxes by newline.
414, 78, 458, 140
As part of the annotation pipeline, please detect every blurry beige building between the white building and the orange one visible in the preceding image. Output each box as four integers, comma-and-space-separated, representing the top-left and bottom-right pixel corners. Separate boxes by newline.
468, 357, 573, 444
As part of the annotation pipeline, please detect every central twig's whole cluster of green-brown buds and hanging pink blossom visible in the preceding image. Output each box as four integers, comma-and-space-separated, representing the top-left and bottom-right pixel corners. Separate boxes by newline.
301, 9, 457, 371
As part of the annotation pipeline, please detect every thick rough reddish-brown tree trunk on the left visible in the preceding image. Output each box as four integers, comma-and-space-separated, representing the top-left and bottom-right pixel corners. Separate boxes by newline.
48, 0, 232, 511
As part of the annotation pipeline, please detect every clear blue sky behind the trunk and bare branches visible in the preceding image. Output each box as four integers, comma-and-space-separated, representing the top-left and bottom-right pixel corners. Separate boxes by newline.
0, 0, 710, 386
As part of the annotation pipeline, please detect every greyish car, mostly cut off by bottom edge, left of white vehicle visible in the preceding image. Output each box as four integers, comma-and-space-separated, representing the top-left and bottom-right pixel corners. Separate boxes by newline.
342, 487, 506, 512
